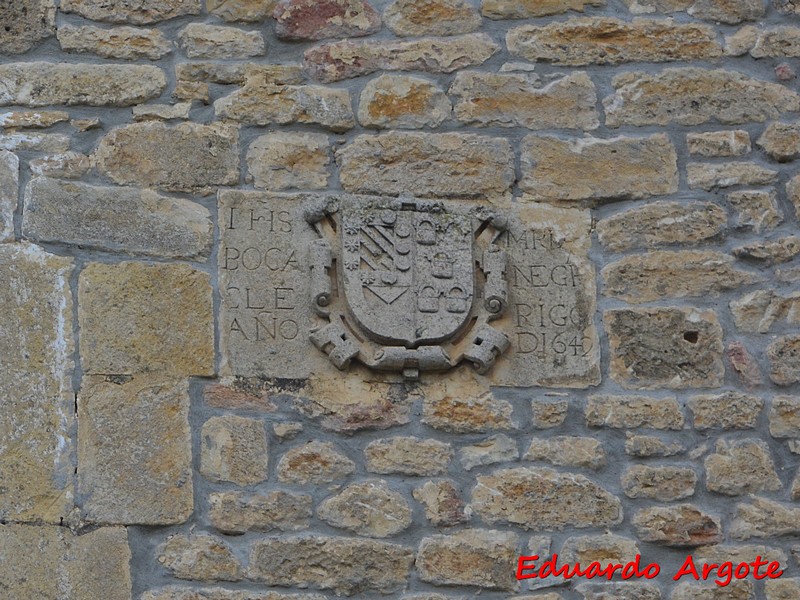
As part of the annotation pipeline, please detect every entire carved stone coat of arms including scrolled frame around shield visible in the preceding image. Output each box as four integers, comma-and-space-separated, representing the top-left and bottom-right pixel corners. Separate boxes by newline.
306, 196, 509, 379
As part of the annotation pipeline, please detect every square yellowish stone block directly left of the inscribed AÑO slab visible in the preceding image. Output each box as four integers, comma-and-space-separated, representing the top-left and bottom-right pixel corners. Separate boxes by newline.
78, 262, 214, 376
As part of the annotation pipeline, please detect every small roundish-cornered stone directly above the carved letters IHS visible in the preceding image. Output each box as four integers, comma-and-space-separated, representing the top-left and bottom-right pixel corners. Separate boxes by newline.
247, 132, 330, 191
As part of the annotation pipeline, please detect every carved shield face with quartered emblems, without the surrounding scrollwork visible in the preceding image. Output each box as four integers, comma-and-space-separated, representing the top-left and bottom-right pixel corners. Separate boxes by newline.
340, 205, 475, 348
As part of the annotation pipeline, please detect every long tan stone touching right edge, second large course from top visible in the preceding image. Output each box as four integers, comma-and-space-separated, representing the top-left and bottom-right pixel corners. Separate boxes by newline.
603, 67, 800, 127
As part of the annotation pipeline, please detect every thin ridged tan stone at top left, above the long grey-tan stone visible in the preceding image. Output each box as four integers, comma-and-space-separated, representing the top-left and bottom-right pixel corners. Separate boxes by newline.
57, 25, 172, 60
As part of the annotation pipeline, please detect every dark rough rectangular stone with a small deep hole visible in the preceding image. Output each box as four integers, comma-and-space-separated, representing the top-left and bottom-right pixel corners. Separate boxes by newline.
604, 308, 725, 390
